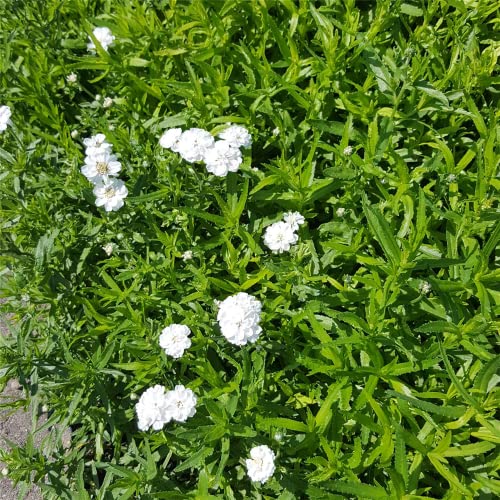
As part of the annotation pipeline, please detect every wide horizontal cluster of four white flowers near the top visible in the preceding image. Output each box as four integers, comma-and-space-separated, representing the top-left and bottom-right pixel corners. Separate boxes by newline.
160, 125, 252, 177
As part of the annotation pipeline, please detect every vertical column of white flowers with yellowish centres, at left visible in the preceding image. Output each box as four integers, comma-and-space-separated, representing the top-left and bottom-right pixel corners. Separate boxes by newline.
81, 134, 128, 212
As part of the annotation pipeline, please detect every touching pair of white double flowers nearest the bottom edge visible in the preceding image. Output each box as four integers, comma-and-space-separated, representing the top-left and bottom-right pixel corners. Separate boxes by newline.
135, 385, 196, 431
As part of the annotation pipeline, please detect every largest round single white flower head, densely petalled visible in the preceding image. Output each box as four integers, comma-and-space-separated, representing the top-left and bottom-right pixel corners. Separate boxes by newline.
217, 292, 262, 346
